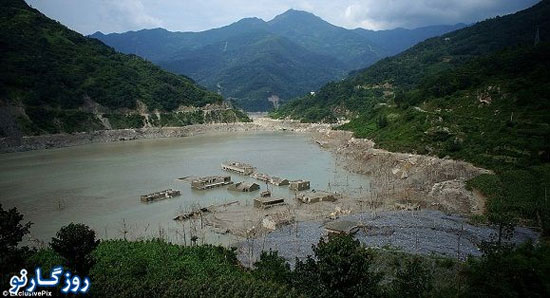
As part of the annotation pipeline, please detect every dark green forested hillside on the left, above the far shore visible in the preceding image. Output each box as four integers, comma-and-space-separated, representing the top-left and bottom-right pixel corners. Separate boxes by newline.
0, 0, 248, 135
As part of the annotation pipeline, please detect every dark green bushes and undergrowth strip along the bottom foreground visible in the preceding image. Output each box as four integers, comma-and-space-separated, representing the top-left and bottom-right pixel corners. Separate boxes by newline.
0, 206, 550, 297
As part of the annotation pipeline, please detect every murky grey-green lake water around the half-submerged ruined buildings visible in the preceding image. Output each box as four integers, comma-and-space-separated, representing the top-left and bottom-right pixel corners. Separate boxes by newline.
0, 132, 368, 242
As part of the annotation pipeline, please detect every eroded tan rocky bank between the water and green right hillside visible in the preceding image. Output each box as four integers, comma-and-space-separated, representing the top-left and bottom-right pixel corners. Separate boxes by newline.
315, 130, 490, 214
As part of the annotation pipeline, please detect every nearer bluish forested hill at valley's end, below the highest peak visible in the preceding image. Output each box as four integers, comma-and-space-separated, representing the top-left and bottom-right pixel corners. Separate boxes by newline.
158, 31, 345, 111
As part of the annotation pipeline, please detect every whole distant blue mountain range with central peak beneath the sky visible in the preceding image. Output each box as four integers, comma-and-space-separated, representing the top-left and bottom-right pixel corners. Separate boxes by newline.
91, 10, 464, 111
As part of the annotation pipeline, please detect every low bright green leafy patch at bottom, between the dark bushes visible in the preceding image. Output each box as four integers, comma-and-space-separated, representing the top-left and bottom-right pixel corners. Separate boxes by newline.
90, 240, 296, 297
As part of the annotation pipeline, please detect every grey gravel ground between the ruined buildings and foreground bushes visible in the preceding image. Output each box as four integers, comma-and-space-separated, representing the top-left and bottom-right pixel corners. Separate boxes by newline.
238, 210, 538, 265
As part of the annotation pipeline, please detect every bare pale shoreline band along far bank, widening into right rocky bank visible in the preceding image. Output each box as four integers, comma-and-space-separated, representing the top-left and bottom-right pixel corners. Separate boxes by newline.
0, 117, 496, 215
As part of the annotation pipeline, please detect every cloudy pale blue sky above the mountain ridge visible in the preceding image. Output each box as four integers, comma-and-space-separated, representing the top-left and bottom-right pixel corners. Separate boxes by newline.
26, 0, 539, 34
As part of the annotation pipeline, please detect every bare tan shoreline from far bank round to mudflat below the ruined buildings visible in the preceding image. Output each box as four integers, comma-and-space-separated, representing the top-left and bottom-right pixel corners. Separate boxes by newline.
4, 117, 520, 259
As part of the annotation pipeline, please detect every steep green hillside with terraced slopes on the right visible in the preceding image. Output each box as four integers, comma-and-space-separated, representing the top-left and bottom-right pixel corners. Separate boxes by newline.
273, 1, 550, 232
